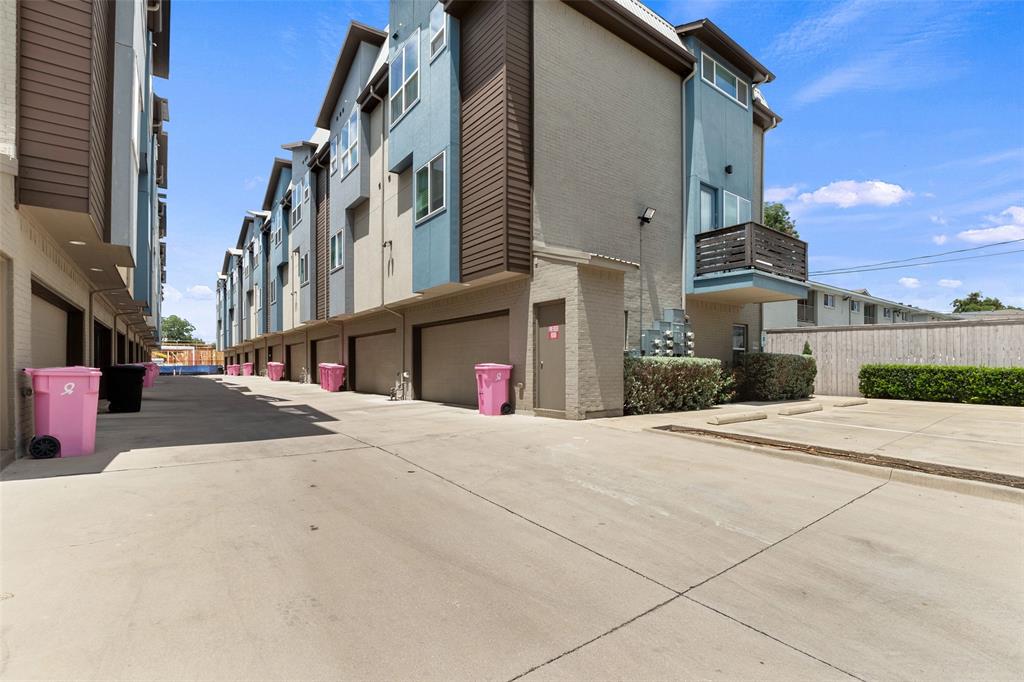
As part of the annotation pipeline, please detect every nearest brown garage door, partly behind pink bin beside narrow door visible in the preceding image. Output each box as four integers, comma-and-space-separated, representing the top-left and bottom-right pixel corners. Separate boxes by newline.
419, 315, 509, 406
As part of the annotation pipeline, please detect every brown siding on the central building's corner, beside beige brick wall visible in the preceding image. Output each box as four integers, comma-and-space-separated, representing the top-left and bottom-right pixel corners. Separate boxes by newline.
460, 0, 532, 282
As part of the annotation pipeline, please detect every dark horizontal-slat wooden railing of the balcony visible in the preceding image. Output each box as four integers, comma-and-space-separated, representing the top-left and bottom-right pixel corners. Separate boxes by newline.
696, 222, 807, 282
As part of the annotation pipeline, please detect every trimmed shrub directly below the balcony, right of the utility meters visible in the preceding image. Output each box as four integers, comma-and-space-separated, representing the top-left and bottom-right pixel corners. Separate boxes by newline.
736, 353, 818, 400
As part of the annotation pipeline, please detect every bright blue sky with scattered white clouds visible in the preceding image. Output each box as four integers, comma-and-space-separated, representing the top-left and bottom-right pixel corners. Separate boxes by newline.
157, 0, 1024, 339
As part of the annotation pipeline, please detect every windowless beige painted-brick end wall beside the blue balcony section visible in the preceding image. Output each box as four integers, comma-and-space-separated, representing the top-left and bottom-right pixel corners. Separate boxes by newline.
534, 2, 684, 346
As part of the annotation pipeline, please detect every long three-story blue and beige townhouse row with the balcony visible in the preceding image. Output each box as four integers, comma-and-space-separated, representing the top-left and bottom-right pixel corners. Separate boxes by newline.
218, 0, 808, 419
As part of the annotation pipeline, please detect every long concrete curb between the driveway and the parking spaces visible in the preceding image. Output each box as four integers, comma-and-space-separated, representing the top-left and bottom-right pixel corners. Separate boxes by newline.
644, 427, 1024, 504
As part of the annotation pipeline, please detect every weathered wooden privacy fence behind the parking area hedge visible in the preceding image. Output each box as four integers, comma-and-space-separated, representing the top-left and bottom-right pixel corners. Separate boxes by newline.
765, 319, 1024, 395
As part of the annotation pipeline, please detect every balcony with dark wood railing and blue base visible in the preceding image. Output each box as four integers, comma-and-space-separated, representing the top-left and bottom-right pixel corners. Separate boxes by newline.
689, 222, 807, 304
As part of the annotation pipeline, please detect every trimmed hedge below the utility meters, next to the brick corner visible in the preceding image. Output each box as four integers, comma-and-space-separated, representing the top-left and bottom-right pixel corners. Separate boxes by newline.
623, 356, 732, 415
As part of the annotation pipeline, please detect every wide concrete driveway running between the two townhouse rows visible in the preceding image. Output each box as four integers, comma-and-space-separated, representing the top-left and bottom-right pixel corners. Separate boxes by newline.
0, 377, 1024, 680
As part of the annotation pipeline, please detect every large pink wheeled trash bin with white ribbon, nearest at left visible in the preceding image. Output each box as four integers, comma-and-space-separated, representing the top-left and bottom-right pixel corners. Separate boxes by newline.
25, 367, 102, 457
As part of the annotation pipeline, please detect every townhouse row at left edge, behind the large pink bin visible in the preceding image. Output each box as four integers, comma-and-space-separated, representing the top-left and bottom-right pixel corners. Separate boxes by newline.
0, 0, 171, 462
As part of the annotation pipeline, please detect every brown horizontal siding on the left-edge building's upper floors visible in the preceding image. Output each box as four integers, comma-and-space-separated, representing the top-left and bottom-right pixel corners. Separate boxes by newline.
17, 0, 115, 238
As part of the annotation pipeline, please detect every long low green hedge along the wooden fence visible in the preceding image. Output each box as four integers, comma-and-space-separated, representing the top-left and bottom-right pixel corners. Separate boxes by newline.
860, 365, 1024, 407
